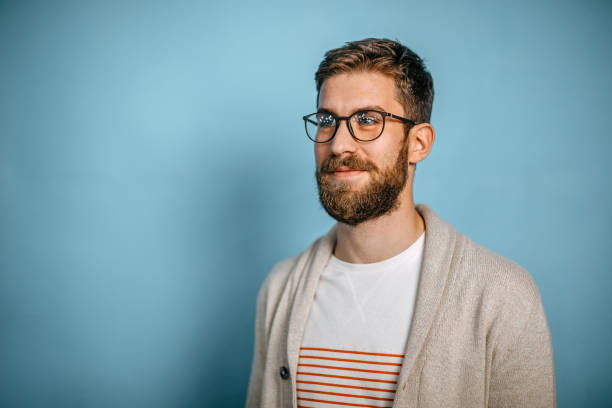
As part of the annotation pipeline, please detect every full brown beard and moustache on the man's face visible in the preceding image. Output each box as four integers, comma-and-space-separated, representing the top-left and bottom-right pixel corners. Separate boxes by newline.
315, 140, 409, 226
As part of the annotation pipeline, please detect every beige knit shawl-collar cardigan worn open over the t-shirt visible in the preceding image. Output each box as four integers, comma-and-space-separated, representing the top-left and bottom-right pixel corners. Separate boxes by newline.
246, 204, 556, 407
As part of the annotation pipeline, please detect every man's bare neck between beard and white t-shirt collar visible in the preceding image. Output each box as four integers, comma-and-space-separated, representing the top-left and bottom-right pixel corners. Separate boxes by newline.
334, 194, 425, 263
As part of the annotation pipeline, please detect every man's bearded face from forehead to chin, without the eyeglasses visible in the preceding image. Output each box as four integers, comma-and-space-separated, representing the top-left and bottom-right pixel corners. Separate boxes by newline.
315, 72, 408, 225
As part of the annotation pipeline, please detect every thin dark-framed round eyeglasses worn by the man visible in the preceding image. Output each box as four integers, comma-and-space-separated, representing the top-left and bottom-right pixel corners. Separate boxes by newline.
302, 110, 417, 143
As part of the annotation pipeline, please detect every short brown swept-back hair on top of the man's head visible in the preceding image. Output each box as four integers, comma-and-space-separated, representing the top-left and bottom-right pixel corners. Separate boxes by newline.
315, 38, 434, 123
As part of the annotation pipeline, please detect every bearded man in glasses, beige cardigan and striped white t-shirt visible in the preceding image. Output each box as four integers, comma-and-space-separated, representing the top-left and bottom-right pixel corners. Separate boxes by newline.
247, 39, 556, 407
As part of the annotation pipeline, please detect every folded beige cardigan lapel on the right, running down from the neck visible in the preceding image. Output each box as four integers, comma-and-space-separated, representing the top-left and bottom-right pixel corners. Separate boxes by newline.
393, 204, 456, 407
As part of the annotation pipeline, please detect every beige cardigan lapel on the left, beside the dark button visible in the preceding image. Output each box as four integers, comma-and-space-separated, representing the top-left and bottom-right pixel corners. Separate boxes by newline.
287, 225, 337, 406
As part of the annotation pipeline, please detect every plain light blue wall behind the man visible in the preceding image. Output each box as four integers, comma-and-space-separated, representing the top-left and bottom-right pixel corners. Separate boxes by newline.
0, 1, 612, 407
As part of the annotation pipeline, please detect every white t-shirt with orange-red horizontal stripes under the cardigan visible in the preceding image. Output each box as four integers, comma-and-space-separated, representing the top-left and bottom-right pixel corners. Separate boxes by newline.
296, 233, 425, 407
